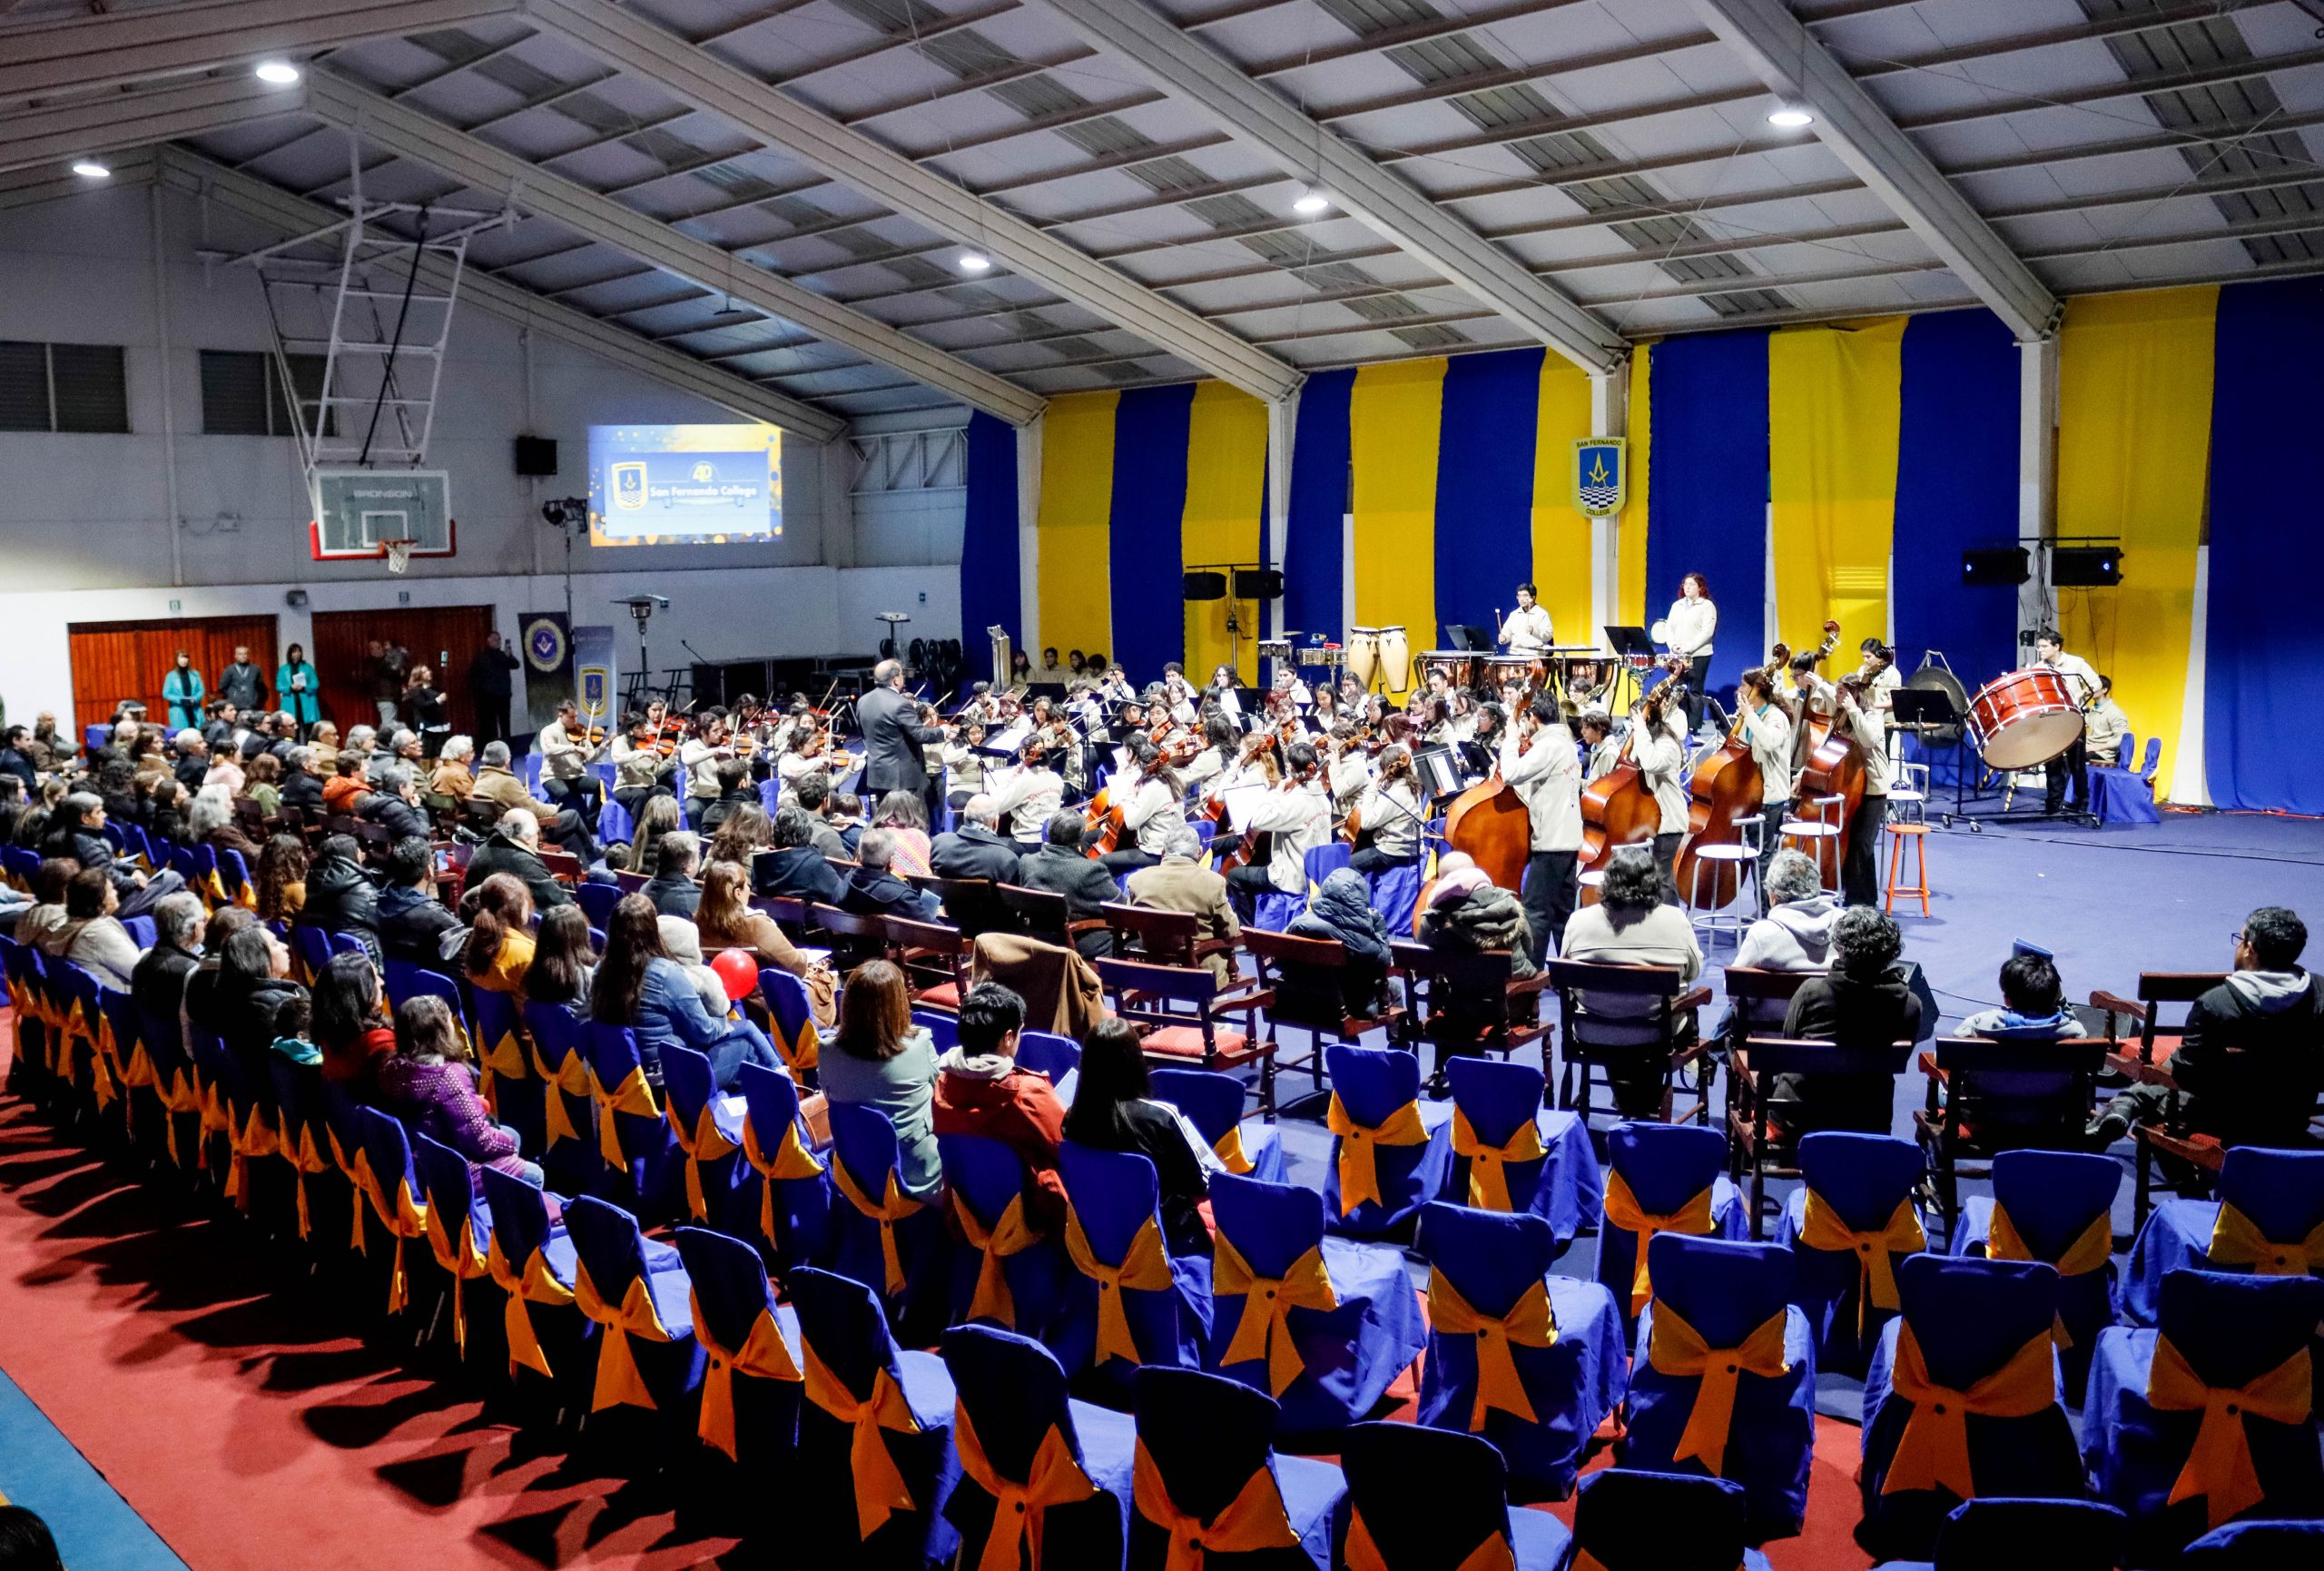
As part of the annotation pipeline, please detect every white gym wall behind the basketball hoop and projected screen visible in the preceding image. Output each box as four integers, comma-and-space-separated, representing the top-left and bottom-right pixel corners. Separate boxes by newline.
0, 188, 962, 716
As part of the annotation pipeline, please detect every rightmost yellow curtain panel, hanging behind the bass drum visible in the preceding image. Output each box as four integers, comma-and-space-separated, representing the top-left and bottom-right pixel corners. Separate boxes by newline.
2057, 288, 2220, 790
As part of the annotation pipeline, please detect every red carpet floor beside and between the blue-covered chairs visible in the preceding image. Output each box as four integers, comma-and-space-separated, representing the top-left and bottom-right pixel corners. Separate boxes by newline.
0, 1015, 1871, 1571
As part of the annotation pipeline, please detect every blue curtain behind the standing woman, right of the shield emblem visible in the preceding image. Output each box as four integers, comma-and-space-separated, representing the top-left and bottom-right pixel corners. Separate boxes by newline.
1645, 330, 1768, 688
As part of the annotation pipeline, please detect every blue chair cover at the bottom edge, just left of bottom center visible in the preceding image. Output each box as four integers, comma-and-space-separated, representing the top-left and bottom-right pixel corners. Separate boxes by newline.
941, 1325, 1137, 1568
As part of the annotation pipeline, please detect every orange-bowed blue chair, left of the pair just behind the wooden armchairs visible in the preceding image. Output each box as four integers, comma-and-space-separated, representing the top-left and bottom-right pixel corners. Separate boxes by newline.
1323, 1043, 1452, 1239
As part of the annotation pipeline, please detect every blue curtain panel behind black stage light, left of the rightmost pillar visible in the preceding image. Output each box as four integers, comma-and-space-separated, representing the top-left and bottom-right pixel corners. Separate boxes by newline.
1896, 311, 2017, 693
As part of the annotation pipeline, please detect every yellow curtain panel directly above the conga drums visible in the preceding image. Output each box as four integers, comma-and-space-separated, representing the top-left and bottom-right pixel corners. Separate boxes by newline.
1348, 356, 1445, 692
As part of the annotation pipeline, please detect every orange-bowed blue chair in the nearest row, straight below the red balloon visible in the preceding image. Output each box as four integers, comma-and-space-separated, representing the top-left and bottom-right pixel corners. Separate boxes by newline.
676, 1227, 804, 1468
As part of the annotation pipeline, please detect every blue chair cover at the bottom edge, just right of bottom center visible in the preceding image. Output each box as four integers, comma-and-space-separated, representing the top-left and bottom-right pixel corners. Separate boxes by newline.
1129, 1368, 1348, 1571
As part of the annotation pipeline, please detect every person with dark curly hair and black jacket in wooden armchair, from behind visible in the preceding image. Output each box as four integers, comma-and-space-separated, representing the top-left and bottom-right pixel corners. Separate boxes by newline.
1775, 906, 1920, 1134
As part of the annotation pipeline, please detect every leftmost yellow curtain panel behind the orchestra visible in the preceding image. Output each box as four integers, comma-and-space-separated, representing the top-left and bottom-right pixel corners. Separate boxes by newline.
1032, 390, 1119, 677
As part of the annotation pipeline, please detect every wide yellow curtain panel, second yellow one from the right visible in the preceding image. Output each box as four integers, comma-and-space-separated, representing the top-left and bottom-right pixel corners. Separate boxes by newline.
1767, 316, 1905, 669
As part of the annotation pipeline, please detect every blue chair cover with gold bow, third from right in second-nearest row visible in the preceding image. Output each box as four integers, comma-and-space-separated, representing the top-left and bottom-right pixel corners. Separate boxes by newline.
1615, 1231, 1815, 1543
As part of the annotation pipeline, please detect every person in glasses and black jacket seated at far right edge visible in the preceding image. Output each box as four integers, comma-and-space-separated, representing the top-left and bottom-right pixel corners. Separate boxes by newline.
2089, 906, 2324, 1151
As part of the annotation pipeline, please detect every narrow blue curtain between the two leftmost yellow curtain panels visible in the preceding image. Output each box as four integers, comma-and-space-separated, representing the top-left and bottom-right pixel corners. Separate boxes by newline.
1107, 381, 1195, 683
